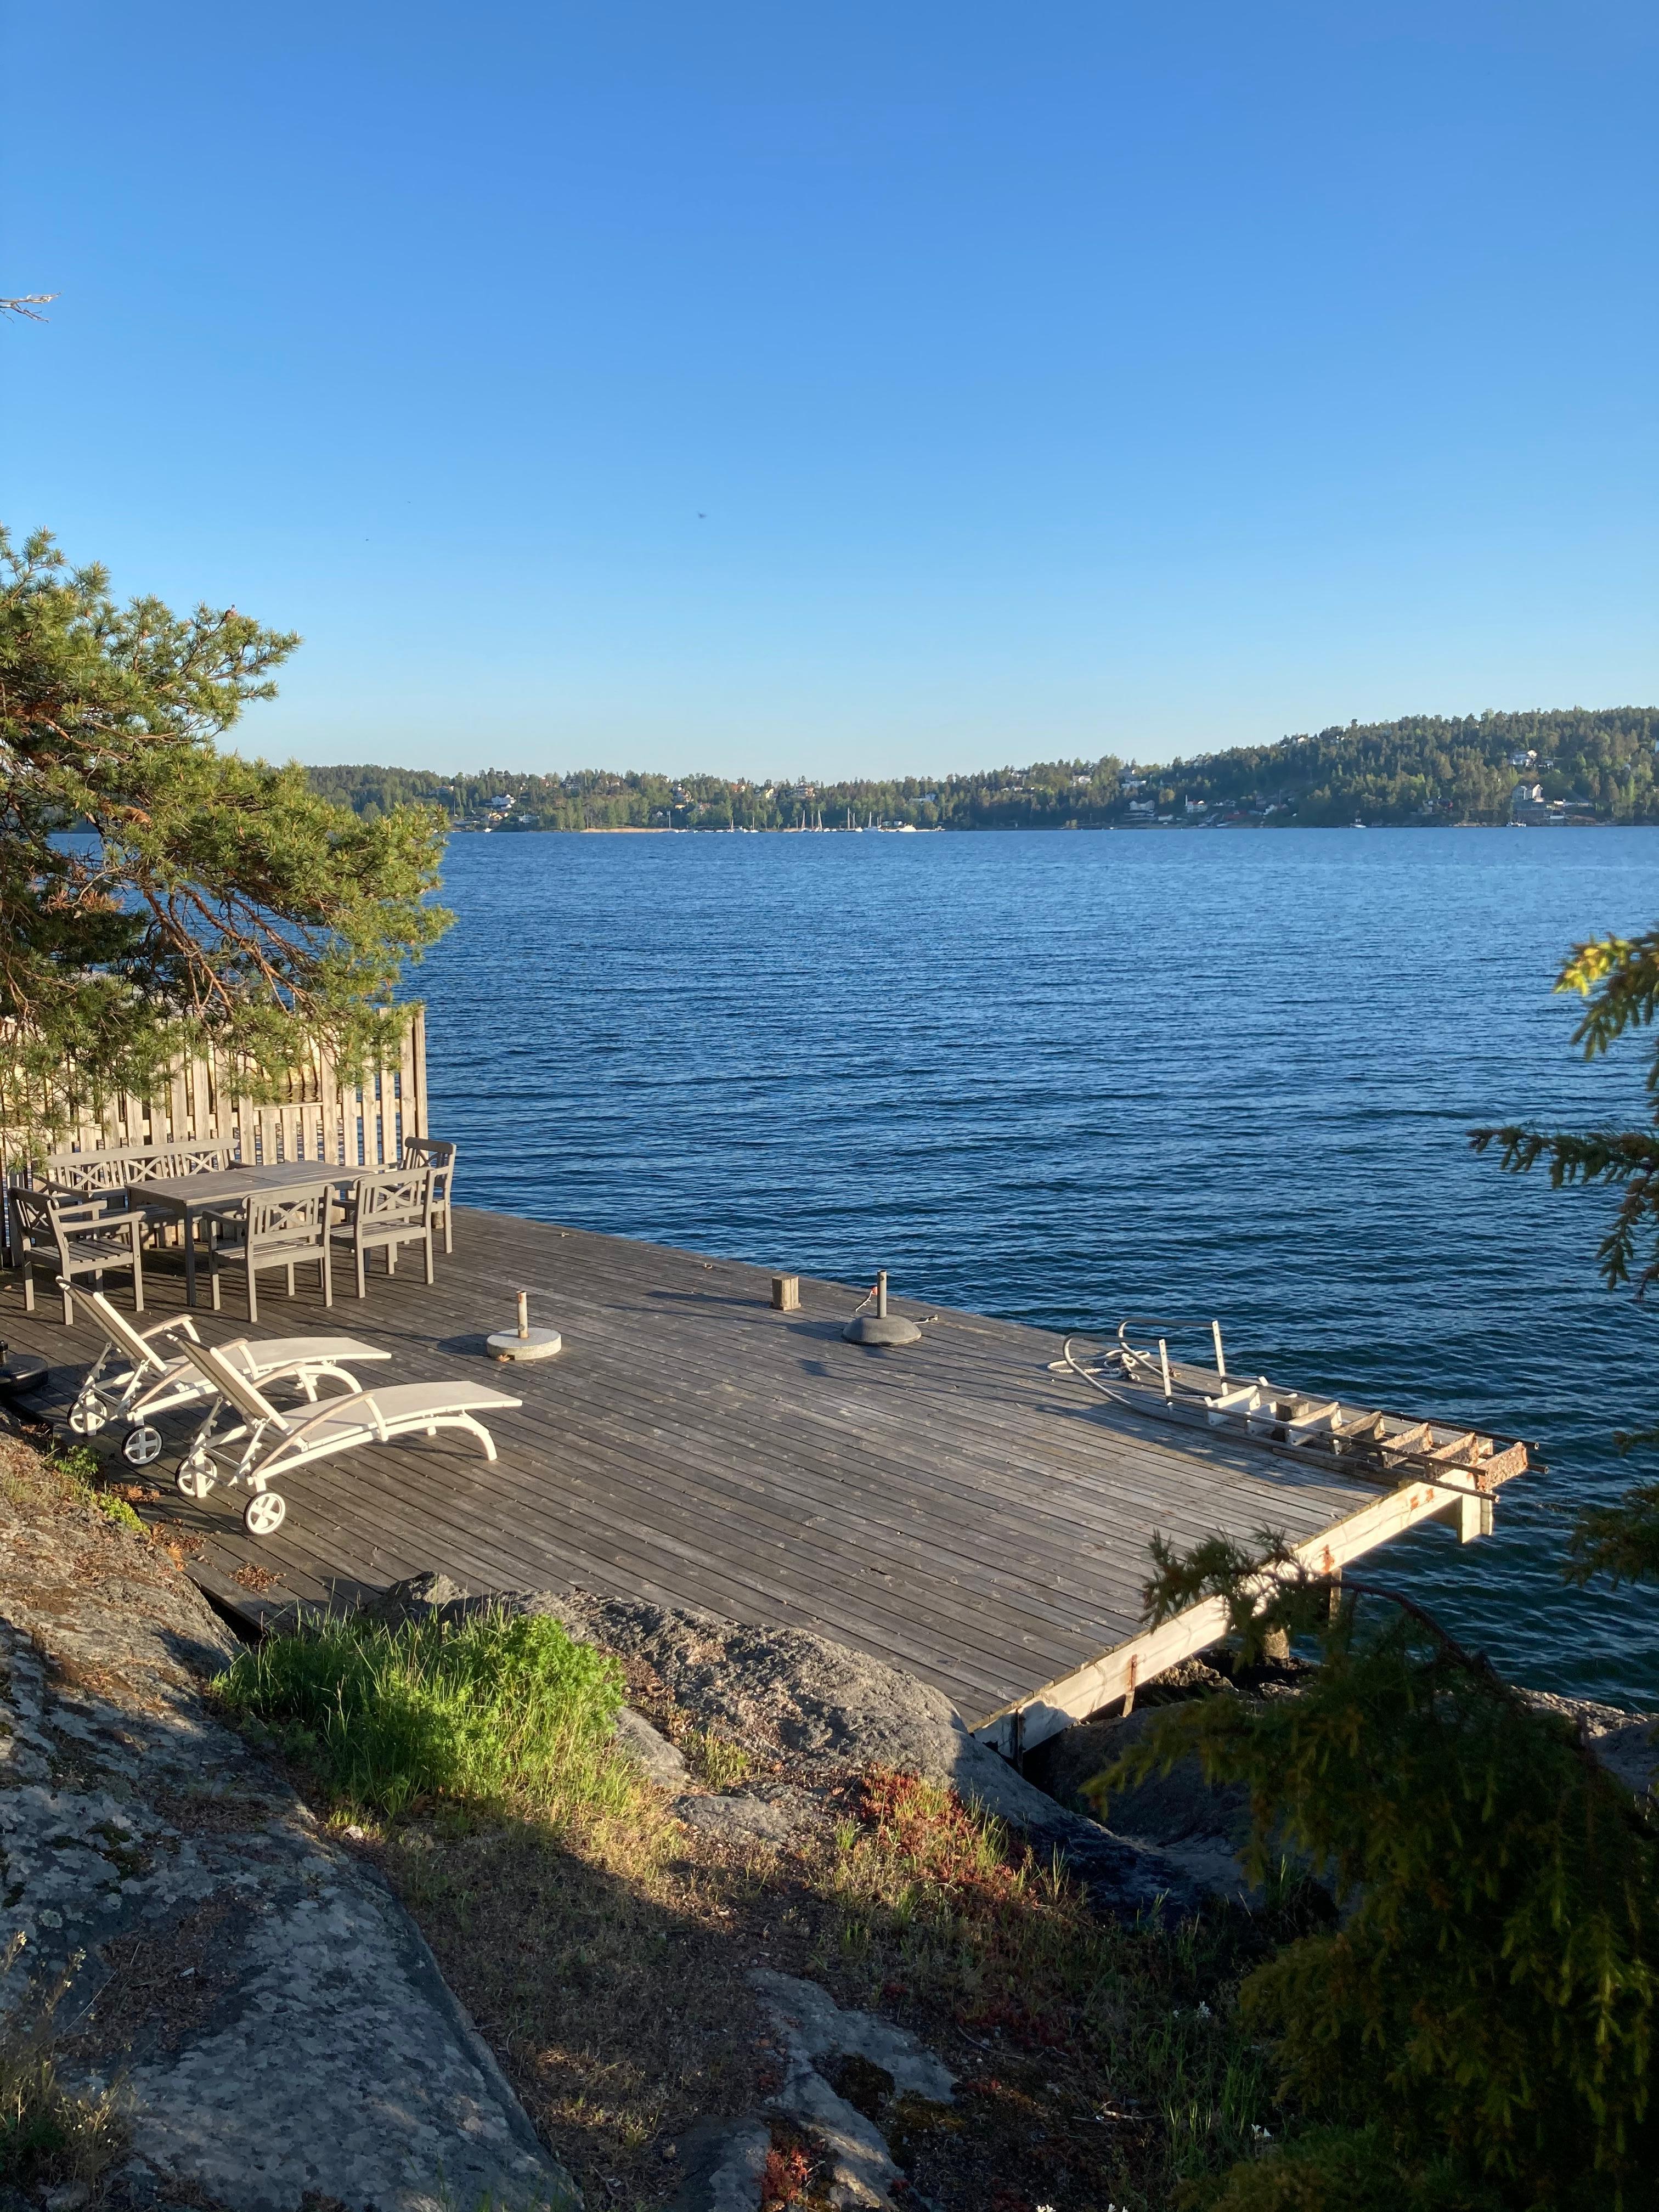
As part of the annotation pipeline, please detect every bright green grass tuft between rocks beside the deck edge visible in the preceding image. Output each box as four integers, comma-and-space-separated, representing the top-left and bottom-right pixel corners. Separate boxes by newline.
215, 1612, 635, 1820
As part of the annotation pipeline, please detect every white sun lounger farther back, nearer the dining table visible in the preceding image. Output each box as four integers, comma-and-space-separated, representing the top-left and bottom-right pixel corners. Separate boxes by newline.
69, 1290, 392, 1466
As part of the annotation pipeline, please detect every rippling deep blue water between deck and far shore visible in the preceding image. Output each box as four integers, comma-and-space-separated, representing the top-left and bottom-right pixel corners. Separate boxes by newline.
418, 830, 1659, 1706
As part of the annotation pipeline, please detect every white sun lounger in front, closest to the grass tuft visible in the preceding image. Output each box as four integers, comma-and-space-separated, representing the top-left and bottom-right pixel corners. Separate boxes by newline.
179, 1340, 524, 1535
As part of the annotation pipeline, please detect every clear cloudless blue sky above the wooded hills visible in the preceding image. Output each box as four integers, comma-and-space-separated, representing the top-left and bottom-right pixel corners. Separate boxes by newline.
0, 0, 1659, 776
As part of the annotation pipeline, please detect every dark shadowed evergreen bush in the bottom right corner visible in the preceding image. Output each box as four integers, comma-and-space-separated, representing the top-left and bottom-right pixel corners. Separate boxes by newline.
1110, 1539, 1659, 2212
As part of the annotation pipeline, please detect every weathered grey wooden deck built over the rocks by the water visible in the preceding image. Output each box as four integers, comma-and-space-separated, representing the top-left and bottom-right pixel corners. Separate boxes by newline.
0, 1210, 1489, 1752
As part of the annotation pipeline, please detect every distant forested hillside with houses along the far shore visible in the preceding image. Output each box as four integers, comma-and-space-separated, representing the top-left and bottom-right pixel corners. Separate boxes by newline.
309, 706, 1659, 830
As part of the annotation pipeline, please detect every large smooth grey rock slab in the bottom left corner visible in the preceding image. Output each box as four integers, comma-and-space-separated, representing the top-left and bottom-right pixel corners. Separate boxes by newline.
0, 1438, 577, 2212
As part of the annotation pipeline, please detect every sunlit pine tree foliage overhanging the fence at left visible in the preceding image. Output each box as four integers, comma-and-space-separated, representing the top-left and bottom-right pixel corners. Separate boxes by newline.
0, 529, 449, 1144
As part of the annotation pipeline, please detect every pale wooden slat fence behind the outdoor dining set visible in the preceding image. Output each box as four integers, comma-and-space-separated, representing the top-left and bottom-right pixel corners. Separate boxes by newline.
0, 1007, 427, 1175
